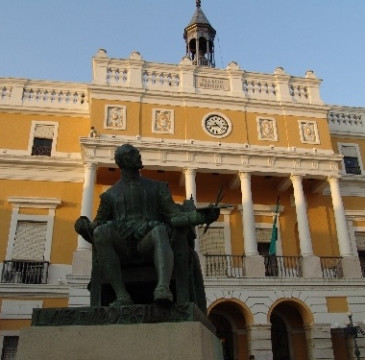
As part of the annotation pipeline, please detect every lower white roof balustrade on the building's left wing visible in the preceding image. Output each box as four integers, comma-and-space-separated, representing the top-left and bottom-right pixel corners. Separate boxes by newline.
0, 78, 89, 113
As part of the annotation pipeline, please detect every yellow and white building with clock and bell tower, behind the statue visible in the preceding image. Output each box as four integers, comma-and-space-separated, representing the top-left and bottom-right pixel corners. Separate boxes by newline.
0, 5, 365, 360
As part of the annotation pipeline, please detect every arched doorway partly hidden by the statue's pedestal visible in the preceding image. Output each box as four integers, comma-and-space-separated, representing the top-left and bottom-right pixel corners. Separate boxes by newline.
209, 301, 249, 360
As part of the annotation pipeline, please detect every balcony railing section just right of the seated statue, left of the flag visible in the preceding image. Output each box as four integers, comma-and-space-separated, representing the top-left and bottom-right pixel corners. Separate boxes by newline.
205, 254, 245, 278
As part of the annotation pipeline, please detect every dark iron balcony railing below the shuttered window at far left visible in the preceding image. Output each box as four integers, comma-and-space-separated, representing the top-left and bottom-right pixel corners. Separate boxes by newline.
1, 260, 49, 284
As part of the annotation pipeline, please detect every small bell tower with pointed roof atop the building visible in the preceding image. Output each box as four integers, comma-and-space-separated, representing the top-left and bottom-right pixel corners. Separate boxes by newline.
184, 0, 216, 67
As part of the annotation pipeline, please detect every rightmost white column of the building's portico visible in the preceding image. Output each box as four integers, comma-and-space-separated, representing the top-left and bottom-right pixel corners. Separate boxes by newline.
328, 177, 353, 256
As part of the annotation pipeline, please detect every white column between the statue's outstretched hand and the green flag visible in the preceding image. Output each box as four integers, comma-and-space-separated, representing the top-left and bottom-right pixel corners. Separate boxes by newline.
239, 171, 258, 256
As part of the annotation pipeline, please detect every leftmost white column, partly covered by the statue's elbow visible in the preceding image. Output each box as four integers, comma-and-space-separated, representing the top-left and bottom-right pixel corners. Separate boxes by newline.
77, 163, 96, 250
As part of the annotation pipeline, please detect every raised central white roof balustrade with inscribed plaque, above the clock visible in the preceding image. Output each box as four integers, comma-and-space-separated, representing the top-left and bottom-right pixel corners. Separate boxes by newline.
92, 49, 323, 105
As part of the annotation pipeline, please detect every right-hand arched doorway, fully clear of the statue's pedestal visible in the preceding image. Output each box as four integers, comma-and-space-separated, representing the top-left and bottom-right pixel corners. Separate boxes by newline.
270, 301, 308, 360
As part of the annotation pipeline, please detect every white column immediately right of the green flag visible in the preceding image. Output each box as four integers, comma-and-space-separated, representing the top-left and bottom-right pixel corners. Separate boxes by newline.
290, 175, 313, 256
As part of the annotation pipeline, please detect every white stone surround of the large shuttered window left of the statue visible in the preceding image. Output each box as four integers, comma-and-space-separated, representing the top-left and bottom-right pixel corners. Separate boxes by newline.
6, 197, 61, 261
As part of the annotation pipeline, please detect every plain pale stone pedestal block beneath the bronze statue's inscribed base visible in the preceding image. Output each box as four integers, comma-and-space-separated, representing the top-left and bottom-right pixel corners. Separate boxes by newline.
16, 322, 223, 360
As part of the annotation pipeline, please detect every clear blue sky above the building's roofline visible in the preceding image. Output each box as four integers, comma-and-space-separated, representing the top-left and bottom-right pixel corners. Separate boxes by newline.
0, 0, 365, 106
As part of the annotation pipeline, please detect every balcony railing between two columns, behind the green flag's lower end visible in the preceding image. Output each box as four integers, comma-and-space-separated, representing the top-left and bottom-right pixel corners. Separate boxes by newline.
264, 255, 302, 277
